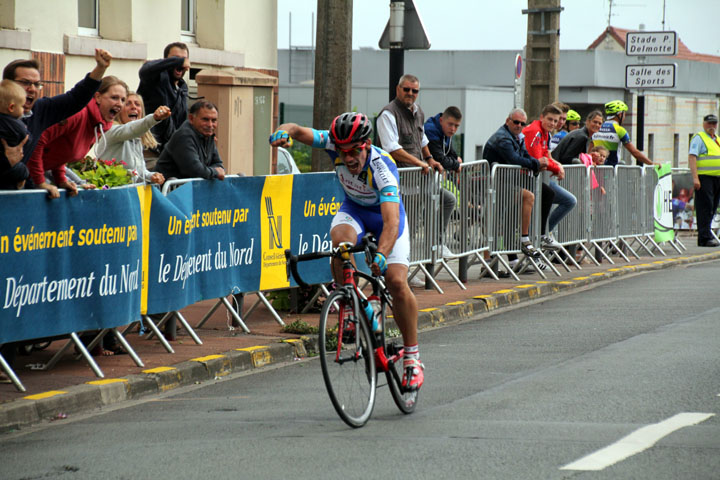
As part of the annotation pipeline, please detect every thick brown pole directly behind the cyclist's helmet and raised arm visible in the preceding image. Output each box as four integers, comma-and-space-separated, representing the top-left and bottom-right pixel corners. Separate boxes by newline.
312, 0, 353, 172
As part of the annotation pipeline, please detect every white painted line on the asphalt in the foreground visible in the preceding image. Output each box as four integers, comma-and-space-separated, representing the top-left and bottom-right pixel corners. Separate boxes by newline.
560, 413, 715, 470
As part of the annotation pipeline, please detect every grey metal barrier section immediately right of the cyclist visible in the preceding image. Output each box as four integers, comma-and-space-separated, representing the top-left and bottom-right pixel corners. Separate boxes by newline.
398, 167, 443, 293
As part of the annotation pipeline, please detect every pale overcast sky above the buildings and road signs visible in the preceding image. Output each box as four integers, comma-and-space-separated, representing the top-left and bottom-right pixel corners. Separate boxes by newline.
277, 0, 720, 55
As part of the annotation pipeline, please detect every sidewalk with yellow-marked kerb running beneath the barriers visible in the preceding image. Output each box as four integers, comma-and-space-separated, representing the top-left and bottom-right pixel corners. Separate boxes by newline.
0, 236, 720, 431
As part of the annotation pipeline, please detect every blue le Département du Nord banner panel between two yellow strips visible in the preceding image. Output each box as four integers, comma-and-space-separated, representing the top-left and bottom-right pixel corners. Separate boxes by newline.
143, 177, 265, 313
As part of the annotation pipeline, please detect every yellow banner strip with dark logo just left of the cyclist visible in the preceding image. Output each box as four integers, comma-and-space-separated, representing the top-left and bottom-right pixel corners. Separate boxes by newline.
260, 175, 294, 290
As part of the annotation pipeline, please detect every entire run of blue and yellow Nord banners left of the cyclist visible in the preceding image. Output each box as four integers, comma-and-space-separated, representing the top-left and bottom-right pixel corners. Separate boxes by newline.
0, 173, 344, 343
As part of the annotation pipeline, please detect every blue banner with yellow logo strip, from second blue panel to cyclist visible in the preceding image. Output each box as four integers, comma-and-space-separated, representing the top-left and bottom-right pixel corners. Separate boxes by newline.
142, 173, 344, 313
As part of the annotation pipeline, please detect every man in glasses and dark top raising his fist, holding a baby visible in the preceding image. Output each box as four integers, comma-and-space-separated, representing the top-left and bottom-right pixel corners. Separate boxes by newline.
3, 49, 112, 188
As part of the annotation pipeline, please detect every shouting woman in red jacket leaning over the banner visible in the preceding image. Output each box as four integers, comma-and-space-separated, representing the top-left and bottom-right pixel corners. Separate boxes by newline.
27, 75, 128, 198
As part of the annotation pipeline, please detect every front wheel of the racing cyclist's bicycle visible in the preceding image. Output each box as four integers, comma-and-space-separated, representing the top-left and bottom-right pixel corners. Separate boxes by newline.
318, 290, 377, 428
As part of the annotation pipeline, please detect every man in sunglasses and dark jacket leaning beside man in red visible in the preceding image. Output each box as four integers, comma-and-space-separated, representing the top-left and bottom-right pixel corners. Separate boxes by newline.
483, 108, 554, 261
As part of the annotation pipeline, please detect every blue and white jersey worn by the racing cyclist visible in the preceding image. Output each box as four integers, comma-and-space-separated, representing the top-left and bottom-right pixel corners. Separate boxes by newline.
312, 129, 405, 236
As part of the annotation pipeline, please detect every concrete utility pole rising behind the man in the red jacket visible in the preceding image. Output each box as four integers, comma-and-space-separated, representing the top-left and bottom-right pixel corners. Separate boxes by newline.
522, 0, 563, 121
